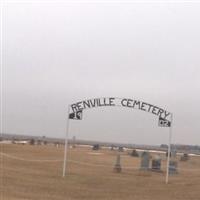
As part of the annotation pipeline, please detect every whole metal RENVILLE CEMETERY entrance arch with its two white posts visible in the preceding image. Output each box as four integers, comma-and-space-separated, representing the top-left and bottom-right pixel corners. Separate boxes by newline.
63, 97, 173, 183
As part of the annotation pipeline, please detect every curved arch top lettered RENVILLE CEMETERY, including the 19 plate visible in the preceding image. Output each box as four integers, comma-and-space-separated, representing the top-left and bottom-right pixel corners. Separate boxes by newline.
69, 97, 171, 122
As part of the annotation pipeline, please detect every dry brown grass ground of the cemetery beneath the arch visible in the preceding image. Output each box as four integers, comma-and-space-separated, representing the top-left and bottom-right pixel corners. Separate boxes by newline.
0, 144, 200, 200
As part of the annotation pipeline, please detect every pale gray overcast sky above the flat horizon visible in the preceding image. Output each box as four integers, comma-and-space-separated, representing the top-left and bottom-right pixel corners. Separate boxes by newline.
3, 1, 200, 145
